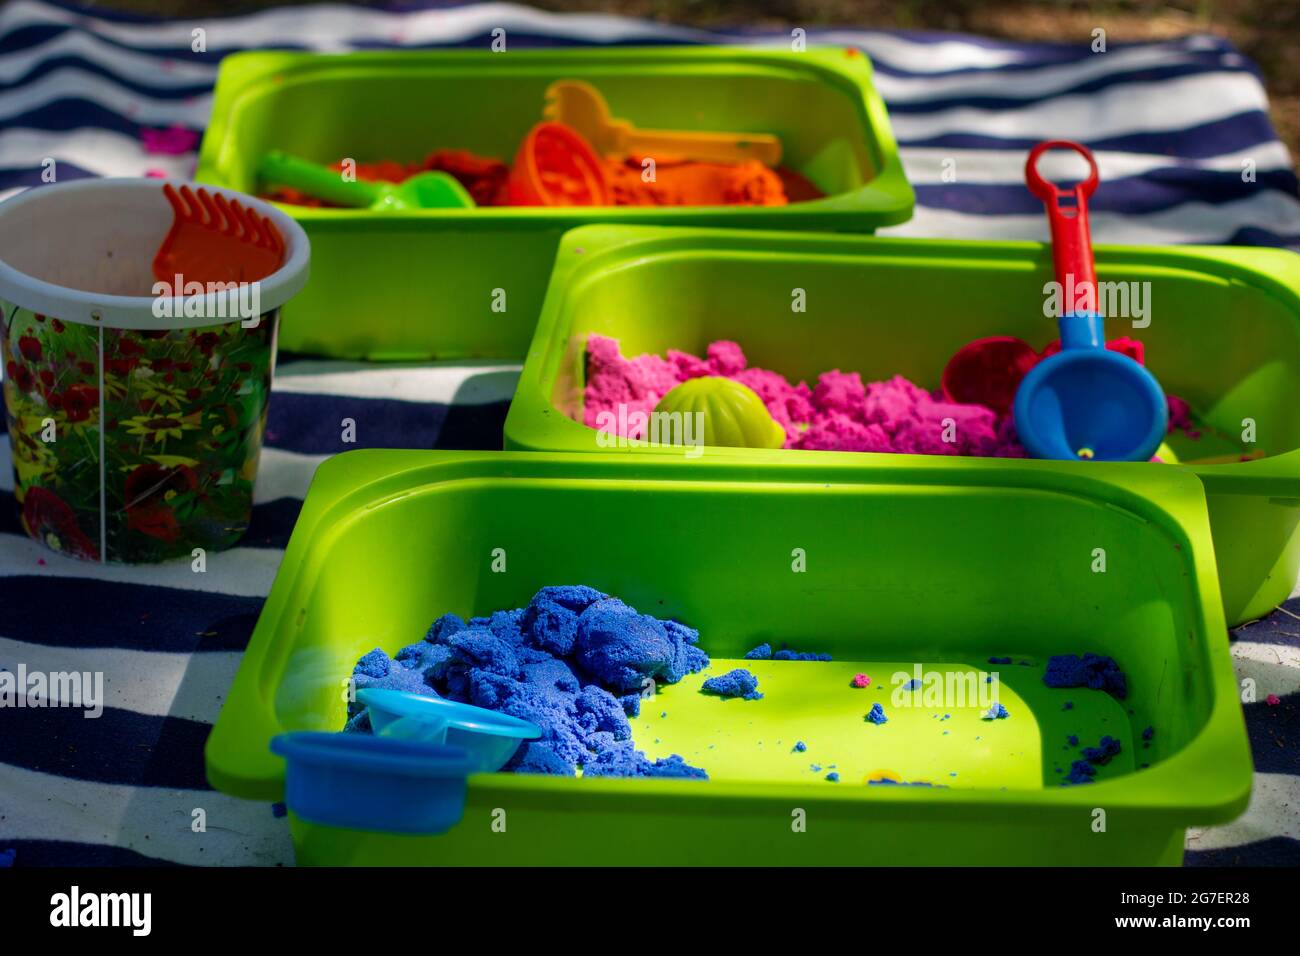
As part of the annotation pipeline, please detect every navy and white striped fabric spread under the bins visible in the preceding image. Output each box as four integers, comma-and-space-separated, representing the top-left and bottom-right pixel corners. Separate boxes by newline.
0, 0, 1300, 865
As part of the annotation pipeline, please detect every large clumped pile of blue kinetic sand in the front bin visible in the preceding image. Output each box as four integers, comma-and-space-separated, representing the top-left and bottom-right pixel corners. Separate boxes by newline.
346, 585, 709, 777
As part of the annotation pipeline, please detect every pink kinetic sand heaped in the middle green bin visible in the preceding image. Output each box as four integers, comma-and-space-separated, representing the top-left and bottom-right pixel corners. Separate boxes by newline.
584, 334, 1024, 458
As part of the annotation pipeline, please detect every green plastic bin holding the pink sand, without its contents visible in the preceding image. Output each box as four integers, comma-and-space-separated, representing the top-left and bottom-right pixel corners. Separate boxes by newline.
506, 226, 1300, 624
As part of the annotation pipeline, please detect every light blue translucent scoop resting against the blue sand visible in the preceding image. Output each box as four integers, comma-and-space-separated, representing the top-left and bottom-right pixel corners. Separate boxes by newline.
356, 687, 542, 773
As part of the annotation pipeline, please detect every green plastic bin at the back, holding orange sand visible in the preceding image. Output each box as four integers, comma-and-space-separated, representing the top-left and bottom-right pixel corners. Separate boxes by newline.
196, 47, 913, 359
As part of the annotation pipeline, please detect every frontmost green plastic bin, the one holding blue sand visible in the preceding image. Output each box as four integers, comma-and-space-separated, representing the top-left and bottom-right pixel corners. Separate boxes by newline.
207, 451, 1252, 865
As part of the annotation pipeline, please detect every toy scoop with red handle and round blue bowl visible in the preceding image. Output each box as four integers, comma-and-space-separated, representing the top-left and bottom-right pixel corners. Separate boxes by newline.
1013, 139, 1169, 462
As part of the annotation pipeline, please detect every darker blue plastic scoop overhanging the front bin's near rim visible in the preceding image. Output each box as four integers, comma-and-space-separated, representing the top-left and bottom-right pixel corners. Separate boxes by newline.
270, 731, 477, 834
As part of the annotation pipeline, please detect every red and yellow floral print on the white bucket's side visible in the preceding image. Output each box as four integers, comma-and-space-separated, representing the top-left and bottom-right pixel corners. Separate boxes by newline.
0, 302, 278, 563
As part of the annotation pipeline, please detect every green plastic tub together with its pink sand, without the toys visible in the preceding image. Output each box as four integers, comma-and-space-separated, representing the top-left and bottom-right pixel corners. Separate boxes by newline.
506, 226, 1300, 623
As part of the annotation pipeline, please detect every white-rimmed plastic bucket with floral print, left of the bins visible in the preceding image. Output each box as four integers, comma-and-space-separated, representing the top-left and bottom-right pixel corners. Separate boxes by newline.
0, 179, 311, 563
